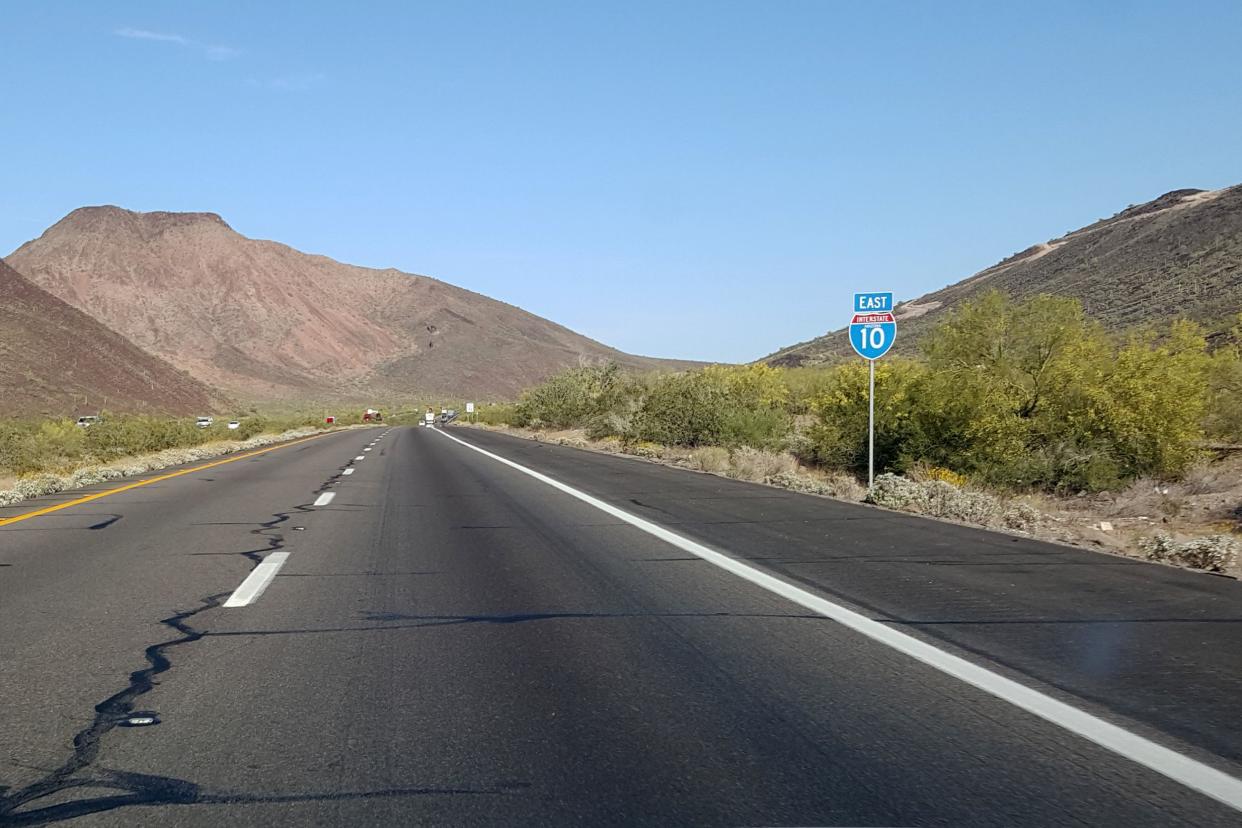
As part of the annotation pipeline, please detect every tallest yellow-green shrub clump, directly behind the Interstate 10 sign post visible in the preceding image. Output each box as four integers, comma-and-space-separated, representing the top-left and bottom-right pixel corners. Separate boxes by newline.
807, 293, 1210, 490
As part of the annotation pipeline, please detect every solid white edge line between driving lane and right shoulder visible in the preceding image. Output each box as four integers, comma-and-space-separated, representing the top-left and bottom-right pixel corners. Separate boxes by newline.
436, 430, 1242, 811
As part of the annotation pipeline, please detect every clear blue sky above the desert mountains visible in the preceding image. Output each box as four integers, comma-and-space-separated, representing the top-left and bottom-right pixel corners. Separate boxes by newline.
0, 0, 1242, 360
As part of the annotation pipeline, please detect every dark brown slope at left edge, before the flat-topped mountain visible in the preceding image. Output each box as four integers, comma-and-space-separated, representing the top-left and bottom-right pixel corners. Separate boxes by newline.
0, 261, 224, 416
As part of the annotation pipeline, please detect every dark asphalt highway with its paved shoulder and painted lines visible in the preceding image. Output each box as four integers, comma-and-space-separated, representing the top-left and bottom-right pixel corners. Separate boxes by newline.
0, 427, 1242, 828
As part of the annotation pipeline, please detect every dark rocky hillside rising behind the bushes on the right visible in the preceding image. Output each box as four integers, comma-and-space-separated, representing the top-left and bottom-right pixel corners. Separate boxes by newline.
761, 185, 1242, 365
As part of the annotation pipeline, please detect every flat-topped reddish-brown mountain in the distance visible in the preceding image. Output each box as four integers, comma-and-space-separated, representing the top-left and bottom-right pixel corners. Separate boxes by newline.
7, 206, 687, 400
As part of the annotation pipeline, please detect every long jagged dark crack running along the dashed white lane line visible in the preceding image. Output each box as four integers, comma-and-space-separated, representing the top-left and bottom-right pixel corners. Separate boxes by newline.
0, 472, 350, 827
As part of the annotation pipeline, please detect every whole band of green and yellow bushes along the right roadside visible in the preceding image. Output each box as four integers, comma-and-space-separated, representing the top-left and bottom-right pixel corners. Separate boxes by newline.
466, 292, 1242, 569
